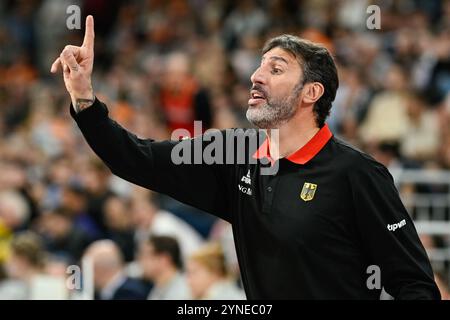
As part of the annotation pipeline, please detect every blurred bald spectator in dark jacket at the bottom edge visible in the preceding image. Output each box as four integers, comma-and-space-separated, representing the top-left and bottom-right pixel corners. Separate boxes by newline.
84, 240, 148, 300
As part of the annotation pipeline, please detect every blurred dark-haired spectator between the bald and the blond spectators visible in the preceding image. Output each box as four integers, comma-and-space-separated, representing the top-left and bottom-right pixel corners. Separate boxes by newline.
139, 236, 191, 300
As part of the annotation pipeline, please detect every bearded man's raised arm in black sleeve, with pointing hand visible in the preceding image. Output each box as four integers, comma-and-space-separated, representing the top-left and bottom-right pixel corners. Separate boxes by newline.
51, 16, 232, 221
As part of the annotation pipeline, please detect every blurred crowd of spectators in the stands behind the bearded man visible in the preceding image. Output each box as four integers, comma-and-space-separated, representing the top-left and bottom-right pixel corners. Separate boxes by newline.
0, 0, 450, 299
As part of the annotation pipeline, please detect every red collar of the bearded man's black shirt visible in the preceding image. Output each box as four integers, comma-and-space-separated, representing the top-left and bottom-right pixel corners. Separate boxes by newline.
253, 124, 333, 164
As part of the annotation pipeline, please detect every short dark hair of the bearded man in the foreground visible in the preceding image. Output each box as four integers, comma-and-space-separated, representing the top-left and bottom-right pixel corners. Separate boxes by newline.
262, 34, 339, 127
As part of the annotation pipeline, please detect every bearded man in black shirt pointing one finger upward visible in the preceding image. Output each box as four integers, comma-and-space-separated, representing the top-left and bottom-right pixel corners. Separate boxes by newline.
52, 16, 440, 299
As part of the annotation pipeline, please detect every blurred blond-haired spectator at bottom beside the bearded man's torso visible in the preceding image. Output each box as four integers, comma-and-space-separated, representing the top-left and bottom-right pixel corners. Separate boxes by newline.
187, 243, 245, 300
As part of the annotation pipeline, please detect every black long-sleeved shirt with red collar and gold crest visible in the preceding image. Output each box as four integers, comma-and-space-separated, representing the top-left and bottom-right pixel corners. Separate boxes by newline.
70, 99, 440, 299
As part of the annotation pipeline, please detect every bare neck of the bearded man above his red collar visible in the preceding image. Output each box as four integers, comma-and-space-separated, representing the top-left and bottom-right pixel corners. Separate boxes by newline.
267, 115, 320, 160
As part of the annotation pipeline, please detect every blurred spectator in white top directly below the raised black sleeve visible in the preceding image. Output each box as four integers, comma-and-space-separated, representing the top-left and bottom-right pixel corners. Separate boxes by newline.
131, 192, 202, 257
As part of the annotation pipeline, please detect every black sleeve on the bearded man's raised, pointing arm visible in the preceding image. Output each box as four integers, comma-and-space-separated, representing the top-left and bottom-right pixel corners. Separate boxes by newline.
70, 99, 231, 222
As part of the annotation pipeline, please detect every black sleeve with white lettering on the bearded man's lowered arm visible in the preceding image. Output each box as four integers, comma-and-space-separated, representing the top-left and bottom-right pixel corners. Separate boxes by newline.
349, 159, 440, 299
